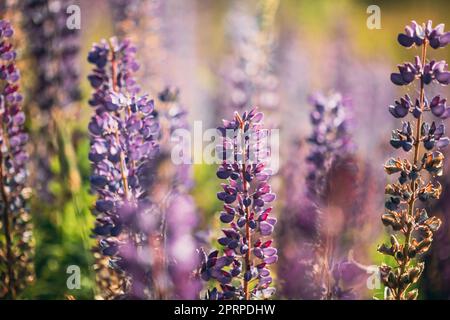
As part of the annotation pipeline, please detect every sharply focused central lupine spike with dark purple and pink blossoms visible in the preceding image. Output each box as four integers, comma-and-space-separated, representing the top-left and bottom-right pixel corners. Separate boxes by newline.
200, 109, 278, 300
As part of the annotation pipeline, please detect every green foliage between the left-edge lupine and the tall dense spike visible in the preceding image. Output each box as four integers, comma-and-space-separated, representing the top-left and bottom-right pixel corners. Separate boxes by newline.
23, 118, 95, 299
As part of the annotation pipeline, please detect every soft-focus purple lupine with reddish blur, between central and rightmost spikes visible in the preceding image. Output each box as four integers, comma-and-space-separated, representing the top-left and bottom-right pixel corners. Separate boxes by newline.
301, 93, 356, 299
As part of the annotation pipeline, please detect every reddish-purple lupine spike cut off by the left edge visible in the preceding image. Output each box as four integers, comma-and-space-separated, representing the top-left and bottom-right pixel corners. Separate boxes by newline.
0, 20, 33, 299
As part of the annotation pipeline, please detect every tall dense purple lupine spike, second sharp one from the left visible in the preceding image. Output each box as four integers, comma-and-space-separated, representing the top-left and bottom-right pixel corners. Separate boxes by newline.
88, 38, 159, 299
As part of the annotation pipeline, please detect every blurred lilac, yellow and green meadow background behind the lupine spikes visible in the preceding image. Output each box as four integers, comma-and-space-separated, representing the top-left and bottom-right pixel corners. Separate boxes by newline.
0, 0, 450, 299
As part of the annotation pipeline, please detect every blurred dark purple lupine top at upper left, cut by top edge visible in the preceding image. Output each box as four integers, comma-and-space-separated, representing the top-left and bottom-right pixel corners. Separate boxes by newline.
22, 0, 80, 110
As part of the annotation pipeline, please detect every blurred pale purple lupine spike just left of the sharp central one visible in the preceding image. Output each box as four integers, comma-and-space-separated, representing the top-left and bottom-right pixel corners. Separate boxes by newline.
152, 86, 200, 299
